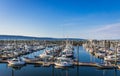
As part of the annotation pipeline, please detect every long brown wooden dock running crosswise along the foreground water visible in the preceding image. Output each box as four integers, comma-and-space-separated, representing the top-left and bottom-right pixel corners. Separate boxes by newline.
0, 59, 117, 69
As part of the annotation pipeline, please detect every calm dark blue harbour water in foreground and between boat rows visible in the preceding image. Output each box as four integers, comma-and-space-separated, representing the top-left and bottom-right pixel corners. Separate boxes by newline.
0, 47, 120, 76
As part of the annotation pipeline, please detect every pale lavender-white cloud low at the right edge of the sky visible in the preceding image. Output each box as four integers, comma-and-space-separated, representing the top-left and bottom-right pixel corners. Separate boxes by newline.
91, 23, 120, 39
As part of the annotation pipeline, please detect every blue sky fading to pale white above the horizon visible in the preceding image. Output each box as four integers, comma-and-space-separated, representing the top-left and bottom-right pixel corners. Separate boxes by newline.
0, 0, 120, 39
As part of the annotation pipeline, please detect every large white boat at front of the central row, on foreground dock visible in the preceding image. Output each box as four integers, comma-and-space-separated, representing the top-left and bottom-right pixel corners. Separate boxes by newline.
55, 57, 73, 67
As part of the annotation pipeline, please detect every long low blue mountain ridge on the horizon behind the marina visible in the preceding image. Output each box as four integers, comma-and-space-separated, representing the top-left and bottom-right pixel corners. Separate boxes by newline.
0, 35, 84, 40
